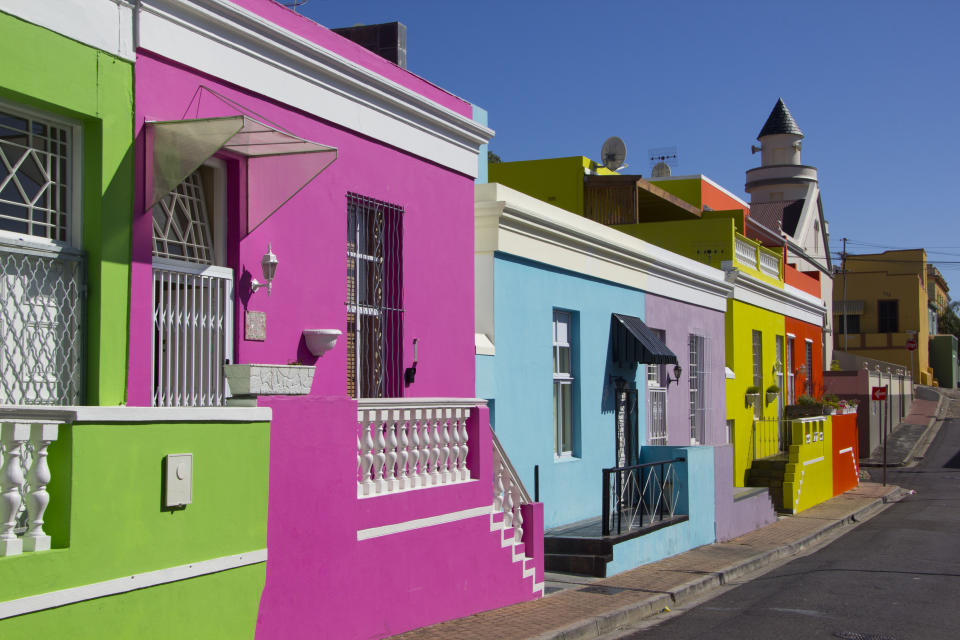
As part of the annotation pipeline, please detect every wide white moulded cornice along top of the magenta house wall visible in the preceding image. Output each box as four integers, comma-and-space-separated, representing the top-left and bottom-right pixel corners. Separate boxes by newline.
137, 0, 493, 177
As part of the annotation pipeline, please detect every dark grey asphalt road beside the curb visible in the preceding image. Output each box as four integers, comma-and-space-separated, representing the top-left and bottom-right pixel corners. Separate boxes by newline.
620, 410, 960, 640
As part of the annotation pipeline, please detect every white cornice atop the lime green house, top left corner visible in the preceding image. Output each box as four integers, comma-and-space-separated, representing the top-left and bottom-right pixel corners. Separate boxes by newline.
0, 0, 134, 61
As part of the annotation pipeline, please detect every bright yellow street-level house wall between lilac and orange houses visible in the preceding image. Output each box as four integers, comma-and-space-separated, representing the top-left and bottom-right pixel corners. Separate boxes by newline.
725, 300, 786, 487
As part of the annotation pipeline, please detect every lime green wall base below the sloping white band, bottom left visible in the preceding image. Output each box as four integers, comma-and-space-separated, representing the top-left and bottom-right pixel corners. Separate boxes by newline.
0, 563, 265, 640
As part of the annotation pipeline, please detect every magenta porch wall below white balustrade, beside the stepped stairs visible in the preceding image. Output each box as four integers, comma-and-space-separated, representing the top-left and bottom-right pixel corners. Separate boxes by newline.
257, 396, 543, 640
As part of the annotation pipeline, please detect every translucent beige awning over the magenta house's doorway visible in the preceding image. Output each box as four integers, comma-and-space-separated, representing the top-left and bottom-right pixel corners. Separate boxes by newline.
146, 115, 337, 233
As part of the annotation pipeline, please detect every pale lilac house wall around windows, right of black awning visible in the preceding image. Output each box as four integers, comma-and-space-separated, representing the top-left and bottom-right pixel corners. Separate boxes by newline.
644, 293, 727, 446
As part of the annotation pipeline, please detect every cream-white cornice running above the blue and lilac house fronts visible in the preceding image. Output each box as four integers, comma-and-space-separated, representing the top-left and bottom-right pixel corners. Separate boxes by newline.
475, 184, 732, 311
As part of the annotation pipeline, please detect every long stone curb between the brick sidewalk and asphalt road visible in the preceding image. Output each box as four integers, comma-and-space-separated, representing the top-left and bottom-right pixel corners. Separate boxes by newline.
530, 487, 907, 640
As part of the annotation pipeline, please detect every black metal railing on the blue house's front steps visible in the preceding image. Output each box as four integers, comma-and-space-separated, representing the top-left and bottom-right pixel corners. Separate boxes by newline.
601, 457, 686, 536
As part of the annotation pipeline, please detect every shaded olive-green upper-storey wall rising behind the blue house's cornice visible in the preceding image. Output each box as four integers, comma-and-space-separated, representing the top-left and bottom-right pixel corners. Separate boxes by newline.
489, 156, 616, 216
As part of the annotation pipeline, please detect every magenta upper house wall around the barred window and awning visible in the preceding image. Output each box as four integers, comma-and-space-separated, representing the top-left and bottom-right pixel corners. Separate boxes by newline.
128, 52, 474, 405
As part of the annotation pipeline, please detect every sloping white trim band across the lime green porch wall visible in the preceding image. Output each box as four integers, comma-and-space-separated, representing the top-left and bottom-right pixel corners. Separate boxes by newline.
0, 549, 267, 620
